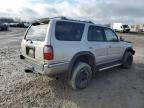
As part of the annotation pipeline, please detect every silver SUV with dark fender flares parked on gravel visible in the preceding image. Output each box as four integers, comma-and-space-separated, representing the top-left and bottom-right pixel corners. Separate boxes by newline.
20, 17, 135, 89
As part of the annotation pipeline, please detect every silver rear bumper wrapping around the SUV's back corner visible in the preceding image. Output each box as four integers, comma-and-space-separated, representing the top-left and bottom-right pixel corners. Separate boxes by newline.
20, 55, 69, 76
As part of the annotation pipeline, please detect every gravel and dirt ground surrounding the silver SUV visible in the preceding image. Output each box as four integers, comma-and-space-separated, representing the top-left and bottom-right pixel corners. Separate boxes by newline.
0, 28, 144, 108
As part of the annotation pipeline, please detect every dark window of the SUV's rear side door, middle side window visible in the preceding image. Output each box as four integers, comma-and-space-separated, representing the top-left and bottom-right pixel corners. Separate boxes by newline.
87, 26, 105, 41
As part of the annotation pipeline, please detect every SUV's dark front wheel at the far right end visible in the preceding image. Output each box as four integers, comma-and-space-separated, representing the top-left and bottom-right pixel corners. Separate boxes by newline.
122, 52, 133, 68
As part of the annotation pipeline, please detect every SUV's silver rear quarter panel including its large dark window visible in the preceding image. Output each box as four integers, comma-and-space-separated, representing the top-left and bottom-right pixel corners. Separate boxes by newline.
51, 20, 85, 63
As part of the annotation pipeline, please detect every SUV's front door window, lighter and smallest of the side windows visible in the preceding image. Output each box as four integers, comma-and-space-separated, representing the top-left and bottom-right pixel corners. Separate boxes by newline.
104, 29, 118, 42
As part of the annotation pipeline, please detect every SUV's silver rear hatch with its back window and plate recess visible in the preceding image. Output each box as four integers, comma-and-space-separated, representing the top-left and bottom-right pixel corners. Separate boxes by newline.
21, 21, 49, 70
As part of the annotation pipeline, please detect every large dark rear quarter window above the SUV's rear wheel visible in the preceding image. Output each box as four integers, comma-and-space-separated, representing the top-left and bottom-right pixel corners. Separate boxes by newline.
55, 21, 85, 41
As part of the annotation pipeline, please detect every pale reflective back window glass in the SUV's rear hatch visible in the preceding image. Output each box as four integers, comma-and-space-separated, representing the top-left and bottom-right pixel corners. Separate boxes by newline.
25, 23, 48, 41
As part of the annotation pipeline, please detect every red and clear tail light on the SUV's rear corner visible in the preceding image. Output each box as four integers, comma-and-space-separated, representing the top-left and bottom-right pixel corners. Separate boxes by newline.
43, 45, 54, 60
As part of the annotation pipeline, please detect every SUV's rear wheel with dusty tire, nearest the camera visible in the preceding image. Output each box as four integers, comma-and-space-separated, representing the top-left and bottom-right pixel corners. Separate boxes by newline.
70, 62, 92, 90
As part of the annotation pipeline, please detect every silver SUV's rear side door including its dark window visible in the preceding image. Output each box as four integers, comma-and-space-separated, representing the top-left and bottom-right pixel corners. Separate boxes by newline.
87, 25, 108, 64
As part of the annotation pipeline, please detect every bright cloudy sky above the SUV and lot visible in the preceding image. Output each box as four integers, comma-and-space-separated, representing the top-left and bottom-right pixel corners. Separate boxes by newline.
0, 0, 144, 23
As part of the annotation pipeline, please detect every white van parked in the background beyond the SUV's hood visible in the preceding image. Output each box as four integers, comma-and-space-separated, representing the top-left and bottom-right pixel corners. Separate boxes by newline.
111, 23, 130, 32
